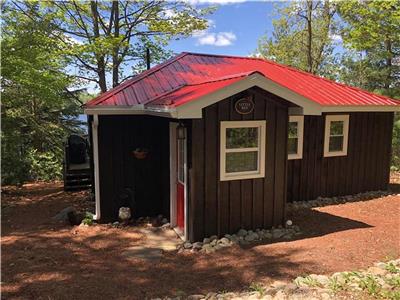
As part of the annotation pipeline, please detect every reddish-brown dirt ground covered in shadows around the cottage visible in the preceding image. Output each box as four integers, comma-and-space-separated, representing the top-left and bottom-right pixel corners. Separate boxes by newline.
1, 183, 400, 299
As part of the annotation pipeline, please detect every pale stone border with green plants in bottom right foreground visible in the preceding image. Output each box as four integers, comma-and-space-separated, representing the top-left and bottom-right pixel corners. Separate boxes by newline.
155, 259, 400, 300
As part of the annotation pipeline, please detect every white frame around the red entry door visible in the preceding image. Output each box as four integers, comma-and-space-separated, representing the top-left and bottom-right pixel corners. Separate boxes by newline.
169, 122, 188, 241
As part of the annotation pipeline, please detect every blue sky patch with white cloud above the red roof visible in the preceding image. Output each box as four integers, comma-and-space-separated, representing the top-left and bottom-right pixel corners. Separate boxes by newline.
169, 0, 278, 56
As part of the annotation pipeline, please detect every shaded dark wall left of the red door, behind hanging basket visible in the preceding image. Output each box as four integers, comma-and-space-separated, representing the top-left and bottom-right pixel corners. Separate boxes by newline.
98, 115, 170, 222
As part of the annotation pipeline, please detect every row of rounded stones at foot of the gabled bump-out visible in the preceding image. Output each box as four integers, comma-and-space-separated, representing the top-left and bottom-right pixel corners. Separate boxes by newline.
178, 225, 302, 253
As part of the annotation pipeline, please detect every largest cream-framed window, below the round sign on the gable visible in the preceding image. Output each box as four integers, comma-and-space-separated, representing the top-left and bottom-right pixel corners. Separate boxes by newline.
220, 121, 266, 181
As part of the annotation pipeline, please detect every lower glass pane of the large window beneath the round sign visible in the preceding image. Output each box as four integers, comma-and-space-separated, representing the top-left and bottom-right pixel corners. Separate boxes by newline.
225, 151, 258, 173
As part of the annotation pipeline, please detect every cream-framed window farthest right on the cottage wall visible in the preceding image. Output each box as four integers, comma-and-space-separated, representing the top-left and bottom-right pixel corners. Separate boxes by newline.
324, 115, 349, 157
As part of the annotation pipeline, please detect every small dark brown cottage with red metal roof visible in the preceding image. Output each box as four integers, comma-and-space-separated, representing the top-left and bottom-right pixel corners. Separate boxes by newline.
85, 53, 400, 241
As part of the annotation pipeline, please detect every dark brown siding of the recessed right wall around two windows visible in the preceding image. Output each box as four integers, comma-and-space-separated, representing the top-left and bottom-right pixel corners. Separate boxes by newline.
287, 112, 393, 202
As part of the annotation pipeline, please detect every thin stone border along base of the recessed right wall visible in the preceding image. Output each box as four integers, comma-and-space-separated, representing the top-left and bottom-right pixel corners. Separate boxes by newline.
286, 191, 396, 211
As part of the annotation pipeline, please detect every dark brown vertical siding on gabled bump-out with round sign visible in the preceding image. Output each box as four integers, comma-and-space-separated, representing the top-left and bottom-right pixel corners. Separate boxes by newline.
188, 88, 288, 241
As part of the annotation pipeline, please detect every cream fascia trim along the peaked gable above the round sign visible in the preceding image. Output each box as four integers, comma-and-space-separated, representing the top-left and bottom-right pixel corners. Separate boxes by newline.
176, 73, 321, 119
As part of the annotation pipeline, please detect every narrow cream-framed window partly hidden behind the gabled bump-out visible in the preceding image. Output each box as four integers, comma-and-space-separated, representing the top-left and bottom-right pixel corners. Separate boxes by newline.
288, 116, 304, 159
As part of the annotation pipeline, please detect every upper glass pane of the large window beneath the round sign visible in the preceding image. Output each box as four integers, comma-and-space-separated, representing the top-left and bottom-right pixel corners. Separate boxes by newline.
226, 127, 258, 149
